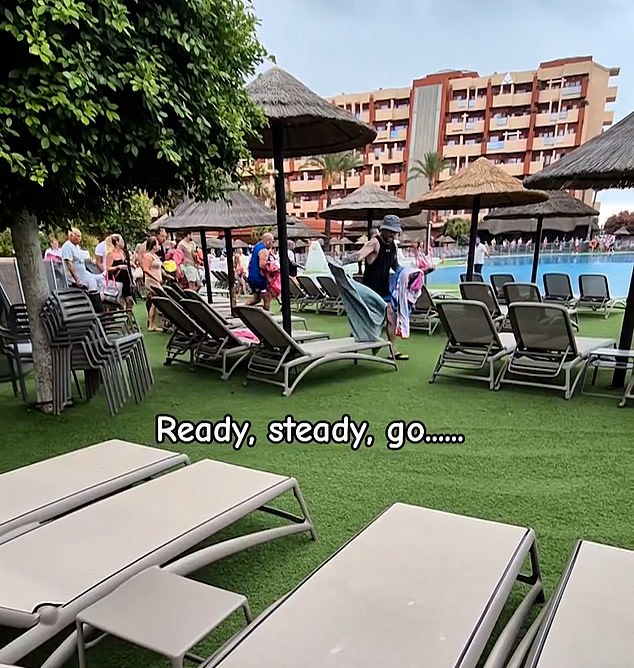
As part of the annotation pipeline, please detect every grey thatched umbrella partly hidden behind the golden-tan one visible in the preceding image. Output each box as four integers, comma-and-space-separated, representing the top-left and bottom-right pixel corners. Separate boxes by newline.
484, 190, 599, 283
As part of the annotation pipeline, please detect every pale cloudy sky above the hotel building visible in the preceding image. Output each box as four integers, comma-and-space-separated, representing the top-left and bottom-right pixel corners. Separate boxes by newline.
252, 0, 634, 221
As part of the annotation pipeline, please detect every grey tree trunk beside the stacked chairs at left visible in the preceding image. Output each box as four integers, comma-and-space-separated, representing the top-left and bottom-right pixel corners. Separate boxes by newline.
11, 213, 53, 413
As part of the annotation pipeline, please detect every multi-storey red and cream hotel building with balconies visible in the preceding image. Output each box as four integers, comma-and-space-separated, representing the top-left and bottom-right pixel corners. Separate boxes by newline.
258, 56, 619, 228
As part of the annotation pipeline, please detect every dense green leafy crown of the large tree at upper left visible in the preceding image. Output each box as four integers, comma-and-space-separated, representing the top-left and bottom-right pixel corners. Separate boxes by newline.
0, 0, 266, 221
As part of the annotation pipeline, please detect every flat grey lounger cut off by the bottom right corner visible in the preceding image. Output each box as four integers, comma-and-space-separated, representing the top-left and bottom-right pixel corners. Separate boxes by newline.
508, 540, 634, 668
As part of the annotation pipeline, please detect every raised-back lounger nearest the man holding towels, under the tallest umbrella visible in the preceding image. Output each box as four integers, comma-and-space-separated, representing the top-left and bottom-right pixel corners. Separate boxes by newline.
236, 306, 397, 397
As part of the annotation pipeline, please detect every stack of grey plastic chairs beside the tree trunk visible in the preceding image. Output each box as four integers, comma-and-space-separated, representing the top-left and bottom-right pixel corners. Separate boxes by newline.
41, 289, 154, 415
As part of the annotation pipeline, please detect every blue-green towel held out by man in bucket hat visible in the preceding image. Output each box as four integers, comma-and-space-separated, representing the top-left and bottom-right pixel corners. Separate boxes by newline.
328, 261, 387, 342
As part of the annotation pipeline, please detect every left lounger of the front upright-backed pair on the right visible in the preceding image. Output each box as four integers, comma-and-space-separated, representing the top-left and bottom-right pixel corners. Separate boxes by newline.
429, 299, 515, 390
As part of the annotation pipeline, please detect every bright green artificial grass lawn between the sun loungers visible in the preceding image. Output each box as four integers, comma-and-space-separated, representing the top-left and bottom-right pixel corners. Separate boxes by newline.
0, 307, 634, 668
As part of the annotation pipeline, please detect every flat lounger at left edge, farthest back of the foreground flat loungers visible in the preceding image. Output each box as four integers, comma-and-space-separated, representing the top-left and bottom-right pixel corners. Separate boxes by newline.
0, 439, 189, 543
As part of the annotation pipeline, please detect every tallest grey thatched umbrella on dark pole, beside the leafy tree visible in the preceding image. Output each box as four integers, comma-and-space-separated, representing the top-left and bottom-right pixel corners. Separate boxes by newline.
247, 67, 376, 333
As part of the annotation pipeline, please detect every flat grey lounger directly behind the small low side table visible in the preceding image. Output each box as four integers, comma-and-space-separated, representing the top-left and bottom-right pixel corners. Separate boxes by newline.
0, 460, 316, 668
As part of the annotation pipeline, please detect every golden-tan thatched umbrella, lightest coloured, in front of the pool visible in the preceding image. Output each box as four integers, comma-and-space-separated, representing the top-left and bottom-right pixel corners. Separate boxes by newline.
411, 158, 548, 281
